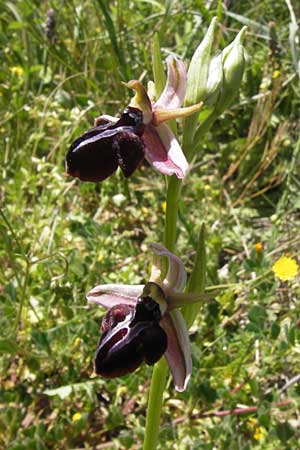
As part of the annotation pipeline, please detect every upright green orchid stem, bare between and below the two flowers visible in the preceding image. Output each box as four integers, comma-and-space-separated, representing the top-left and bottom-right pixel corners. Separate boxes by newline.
143, 176, 181, 450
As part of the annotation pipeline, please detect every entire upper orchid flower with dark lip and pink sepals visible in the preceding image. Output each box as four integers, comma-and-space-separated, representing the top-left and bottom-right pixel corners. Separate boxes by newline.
66, 55, 202, 181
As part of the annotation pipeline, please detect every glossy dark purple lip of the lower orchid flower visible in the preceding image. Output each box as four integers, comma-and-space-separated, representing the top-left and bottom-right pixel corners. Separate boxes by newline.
94, 288, 168, 378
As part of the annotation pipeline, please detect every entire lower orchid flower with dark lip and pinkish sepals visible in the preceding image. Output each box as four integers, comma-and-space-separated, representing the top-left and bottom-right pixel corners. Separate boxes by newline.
87, 243, 209, 392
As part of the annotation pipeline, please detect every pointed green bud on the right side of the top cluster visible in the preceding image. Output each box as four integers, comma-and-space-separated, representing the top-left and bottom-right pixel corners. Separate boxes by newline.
216, 27, 247, 114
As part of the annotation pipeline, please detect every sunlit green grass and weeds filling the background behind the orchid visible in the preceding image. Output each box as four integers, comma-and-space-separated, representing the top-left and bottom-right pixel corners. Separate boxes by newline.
0, 0, 300, 450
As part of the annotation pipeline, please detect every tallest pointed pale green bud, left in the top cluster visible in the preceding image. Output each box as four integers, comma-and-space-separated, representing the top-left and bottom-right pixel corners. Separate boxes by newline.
185, 17, 217, 106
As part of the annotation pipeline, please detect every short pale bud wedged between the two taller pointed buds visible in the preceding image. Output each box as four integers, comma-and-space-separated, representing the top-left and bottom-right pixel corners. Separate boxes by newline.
203, 53, 223, 106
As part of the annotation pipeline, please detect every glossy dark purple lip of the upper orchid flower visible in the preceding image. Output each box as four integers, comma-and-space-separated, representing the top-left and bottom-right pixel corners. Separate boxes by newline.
66, 107, 145, 182
